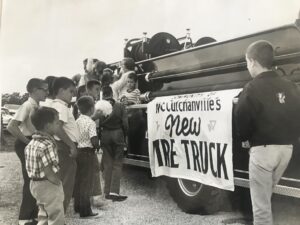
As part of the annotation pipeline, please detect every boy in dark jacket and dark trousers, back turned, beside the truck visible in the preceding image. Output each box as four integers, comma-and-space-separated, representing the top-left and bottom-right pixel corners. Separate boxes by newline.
99, 86, 128, 201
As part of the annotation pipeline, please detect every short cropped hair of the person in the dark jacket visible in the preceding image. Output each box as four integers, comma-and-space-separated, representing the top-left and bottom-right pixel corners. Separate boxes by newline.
246, 40, 274, 69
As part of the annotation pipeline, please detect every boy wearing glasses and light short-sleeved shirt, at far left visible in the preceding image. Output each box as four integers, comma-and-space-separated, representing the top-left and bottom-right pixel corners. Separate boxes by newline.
7, 78, 48, 225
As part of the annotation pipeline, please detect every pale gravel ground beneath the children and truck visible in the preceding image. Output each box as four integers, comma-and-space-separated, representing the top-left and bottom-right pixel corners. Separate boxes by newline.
0, 133, 299, 225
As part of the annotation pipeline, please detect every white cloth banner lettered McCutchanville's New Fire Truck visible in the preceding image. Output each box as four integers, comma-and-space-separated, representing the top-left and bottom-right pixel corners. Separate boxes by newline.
147, 89, 241, 191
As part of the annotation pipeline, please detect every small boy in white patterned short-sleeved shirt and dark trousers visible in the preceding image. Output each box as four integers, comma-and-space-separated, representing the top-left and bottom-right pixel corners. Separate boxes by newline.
74, 96, 99, 217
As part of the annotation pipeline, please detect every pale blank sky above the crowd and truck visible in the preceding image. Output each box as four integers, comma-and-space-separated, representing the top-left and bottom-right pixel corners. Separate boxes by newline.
0, 0, 300, 93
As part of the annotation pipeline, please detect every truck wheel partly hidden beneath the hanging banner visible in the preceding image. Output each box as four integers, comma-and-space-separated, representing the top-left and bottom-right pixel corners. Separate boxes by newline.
167, 178, 225, 214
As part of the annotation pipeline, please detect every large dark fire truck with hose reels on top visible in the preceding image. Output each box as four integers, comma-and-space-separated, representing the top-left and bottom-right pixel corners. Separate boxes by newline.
110, 16, 300, 213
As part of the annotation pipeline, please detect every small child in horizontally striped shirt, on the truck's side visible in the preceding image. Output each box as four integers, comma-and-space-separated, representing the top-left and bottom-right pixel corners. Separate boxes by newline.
120, 73, 141, 106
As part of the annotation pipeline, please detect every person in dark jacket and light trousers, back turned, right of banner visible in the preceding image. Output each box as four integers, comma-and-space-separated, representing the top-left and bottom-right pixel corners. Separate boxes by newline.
235, 41, 300, 225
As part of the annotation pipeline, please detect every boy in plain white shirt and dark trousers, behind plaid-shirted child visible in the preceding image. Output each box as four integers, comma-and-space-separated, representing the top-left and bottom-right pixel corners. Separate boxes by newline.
51, 77, 79, 212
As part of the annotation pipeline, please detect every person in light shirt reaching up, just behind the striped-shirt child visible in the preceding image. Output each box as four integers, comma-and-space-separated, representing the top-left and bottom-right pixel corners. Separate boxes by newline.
111, 58, 135, 101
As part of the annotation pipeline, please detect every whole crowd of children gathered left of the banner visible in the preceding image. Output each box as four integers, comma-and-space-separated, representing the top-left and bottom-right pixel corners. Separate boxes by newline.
8, 58, 140, 225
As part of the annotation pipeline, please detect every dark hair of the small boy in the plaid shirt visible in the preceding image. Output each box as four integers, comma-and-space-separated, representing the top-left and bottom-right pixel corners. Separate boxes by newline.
31, 107, 58, 131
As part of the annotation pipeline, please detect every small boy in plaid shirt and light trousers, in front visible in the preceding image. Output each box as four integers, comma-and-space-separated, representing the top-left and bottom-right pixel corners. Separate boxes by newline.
25, 107, 64, 225
